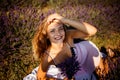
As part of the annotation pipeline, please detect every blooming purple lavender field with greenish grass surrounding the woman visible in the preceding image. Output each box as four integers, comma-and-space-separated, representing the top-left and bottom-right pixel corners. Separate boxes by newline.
0, 0, 120, 80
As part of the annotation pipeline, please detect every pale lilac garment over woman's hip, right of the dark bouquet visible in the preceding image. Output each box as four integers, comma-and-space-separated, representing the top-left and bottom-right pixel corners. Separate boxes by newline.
74, 41, 100, 80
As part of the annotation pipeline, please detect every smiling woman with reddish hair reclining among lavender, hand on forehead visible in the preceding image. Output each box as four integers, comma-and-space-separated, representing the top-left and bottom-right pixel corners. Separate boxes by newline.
23, 13, 100, 80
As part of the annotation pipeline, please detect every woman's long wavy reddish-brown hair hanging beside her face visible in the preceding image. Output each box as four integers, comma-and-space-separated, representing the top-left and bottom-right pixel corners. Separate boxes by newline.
32, 18, 66, 60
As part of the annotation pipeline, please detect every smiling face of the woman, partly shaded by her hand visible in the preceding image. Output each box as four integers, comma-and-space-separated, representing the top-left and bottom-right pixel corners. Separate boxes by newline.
47, 21, 65, 43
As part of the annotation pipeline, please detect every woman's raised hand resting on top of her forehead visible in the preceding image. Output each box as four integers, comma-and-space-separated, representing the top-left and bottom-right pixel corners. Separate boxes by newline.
47, 13, 63, 24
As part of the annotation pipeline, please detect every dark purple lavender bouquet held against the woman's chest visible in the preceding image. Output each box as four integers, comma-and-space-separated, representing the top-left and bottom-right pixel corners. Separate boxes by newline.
56, 47, 80, 79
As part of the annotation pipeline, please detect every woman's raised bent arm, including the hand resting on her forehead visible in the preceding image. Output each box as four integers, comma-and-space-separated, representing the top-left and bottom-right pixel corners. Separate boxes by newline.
47, 13, 97, 39
